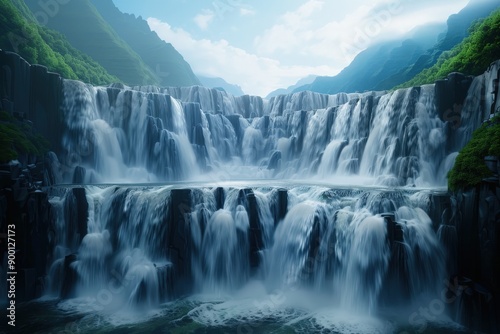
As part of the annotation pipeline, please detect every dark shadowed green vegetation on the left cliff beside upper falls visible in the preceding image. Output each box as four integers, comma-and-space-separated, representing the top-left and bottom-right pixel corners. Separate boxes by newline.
0, 111, 49, 162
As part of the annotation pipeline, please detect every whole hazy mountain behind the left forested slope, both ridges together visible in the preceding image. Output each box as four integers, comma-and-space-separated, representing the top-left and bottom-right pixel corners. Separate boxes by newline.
20, 0, 200, 86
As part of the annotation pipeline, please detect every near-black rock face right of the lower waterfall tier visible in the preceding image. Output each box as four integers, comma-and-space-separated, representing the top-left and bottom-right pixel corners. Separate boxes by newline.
450, 178, 500, 333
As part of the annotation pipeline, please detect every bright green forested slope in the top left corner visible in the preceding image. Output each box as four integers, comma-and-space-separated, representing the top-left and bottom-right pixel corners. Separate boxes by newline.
0, 0, 119, 84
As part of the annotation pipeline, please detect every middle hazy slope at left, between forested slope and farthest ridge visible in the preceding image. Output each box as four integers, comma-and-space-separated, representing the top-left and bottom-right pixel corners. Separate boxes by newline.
25, 0, 159, 85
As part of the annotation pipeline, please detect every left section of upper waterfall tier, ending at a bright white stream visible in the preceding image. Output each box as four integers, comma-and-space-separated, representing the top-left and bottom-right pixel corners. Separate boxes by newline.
62, 80, 198, 183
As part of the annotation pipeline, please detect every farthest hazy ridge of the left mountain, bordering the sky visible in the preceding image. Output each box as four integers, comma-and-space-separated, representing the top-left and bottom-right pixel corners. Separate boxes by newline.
92, 0, 200, 86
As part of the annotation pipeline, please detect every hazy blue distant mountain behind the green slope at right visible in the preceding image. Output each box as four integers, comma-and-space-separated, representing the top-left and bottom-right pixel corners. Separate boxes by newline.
295, 0, 500, 94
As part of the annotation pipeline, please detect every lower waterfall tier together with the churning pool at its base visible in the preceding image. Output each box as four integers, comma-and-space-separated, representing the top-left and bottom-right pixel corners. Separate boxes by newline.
0, 181, 466, 333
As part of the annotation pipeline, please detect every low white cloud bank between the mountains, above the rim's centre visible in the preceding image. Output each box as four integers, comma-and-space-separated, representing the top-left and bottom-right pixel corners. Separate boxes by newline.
147, 18, 339, 96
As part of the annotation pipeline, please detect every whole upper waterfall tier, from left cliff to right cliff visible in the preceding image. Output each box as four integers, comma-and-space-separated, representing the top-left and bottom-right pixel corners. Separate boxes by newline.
60, 63, 499, 187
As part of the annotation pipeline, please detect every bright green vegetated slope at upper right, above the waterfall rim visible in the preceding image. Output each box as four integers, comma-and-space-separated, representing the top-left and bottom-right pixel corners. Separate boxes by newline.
396, 10, 500, 88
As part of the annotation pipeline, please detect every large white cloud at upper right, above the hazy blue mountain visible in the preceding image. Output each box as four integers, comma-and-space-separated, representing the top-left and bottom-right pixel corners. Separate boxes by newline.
254, 0, 467, 66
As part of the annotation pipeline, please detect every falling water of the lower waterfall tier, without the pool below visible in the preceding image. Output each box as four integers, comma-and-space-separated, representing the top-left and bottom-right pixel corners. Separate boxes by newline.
44, 185, 446, 328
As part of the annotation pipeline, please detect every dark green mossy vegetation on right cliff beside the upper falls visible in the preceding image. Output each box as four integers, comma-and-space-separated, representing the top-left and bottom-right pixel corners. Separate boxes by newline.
448, 116, 500, 191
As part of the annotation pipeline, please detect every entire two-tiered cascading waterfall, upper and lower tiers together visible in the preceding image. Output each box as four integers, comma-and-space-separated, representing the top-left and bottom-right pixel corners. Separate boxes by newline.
30, 61, 496, 333
